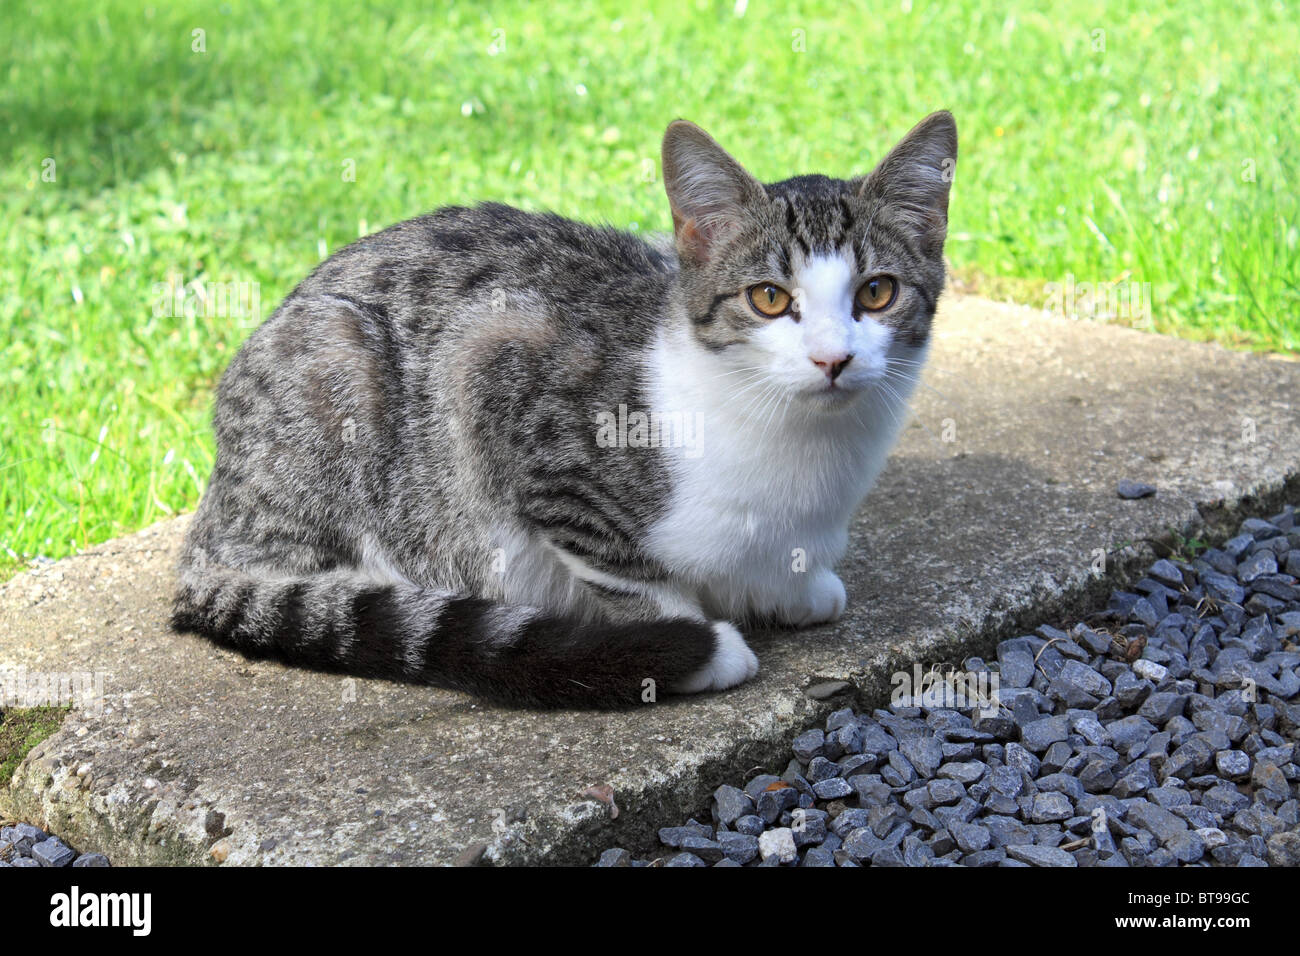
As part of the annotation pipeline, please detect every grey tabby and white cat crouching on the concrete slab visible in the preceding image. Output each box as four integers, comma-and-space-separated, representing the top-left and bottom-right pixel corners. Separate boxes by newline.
172, 112, 957, 708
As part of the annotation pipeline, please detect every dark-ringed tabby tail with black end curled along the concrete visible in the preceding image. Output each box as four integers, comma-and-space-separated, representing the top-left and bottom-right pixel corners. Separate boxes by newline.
172, 564, 733, 708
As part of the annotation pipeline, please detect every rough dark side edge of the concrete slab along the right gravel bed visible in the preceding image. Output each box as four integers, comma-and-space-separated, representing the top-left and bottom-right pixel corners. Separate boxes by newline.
488, 472, 1300, 866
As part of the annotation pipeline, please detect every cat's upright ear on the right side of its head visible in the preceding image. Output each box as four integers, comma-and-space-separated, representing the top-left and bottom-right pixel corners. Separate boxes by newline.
858, 109, 957, 254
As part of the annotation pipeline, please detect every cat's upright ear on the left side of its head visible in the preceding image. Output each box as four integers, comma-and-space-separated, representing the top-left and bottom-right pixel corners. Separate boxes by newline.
663, 120, 766, 261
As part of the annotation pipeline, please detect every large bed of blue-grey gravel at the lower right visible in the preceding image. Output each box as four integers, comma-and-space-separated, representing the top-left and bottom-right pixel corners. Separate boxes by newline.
595, 509, 1300, 866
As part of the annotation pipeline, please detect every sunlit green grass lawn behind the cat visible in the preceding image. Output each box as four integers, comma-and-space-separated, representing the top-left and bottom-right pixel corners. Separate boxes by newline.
0, 0, 1300, 568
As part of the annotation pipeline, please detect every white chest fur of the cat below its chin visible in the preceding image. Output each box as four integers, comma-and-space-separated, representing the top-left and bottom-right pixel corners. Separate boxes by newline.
646, 323, 911, 617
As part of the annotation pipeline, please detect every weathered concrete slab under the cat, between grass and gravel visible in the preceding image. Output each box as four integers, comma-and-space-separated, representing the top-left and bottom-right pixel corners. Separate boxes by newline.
0, 298, 1300, 864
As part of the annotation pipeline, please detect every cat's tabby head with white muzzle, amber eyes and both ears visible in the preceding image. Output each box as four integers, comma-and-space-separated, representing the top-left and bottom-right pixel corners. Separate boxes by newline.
663, 112, 957, 406
